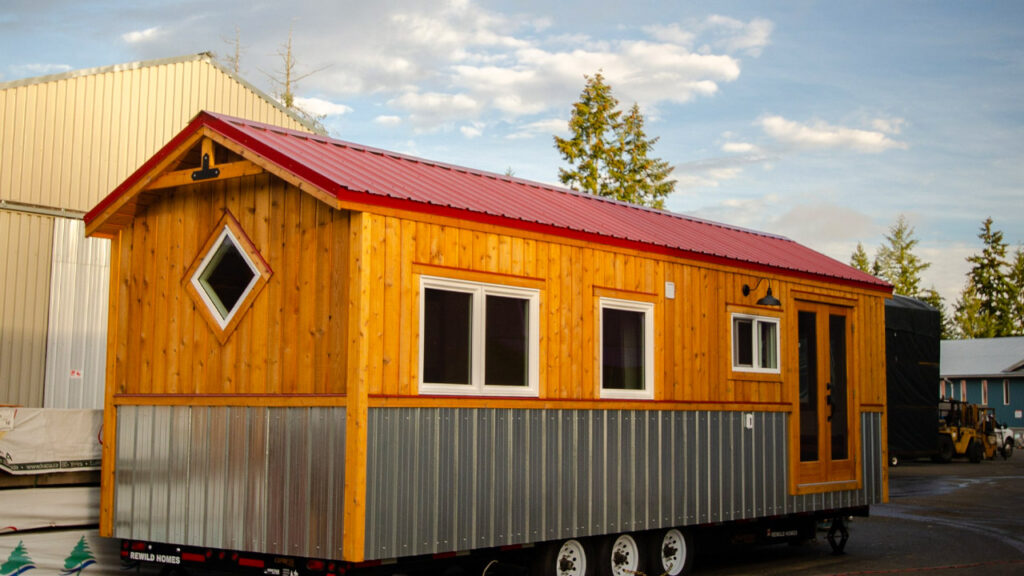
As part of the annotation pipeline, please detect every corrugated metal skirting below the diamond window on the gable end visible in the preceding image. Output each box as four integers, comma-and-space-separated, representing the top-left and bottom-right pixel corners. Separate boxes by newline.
114, 406, 345, 559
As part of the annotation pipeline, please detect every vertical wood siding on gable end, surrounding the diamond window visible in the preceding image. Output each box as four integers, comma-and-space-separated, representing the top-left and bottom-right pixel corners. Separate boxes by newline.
107, 174, 348, 395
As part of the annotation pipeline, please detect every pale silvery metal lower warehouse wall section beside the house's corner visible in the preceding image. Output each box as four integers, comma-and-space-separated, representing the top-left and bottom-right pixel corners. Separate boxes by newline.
43, 218, 111, 409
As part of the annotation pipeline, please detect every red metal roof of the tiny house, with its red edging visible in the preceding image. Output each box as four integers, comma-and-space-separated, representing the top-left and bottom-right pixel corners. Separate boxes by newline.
85, 112, 892, 292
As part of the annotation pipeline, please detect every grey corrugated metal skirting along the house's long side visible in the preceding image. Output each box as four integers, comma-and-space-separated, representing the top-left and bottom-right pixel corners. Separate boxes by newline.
366, 408, 882, 559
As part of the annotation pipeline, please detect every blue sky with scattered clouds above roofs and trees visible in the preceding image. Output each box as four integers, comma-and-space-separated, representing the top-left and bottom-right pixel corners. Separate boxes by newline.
0, 0, 1024, 303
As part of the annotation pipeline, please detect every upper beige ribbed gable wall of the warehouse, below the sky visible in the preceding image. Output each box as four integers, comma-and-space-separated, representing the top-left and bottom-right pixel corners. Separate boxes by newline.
0, 54, 310, 211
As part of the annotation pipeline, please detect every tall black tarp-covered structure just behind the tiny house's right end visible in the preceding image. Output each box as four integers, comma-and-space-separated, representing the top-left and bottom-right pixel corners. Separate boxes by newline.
886, 295, 942, 458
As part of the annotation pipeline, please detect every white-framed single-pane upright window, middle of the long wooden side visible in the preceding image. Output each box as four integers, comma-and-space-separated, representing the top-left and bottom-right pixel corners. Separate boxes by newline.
598, 298, 654, 400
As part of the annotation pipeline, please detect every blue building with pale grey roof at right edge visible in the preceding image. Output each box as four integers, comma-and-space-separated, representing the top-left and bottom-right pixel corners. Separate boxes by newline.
939, 336, 1024, 430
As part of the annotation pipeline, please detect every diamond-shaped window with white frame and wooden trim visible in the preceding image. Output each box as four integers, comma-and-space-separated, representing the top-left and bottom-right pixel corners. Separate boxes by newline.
185, 213, 271, 342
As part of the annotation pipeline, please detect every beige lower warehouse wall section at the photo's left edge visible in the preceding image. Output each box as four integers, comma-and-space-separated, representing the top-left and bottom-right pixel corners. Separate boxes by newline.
0, 209, 53, 408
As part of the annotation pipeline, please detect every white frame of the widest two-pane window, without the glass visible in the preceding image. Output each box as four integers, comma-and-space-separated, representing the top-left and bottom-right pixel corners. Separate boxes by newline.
419, 276, 541, 398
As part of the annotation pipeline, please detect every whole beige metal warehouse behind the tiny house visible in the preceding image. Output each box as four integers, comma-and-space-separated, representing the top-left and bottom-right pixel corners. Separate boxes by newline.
0, 53, 313, 408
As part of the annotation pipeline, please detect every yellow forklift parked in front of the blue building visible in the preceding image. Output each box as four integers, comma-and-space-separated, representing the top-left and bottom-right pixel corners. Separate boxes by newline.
935, 400, 1001, 462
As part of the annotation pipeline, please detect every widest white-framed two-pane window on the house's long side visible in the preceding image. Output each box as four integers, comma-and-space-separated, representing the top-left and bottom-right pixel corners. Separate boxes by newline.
420, 276, 541, 396
